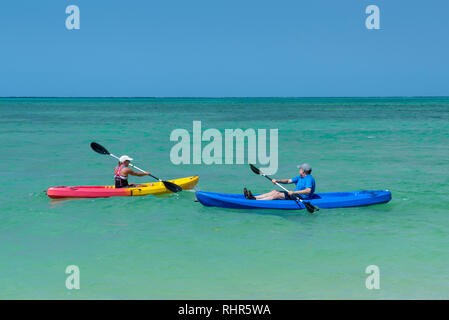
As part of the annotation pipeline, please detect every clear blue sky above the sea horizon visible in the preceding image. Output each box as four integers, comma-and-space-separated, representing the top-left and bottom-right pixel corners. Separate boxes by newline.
0, 0, 449, 97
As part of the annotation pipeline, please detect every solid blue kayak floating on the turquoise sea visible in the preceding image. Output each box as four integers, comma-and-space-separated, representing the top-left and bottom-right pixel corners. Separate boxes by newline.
195, 190, 391, 210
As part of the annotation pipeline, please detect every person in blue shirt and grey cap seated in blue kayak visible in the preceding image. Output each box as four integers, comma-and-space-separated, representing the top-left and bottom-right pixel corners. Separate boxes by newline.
243, 163, 315, 200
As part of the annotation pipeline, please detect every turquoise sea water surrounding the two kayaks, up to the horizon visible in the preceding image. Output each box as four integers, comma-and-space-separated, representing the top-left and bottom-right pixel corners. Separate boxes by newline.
0, 98, 449, 299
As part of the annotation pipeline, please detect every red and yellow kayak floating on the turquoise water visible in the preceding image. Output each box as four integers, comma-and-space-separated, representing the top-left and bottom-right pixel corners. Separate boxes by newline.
47, 176, 199, 199
